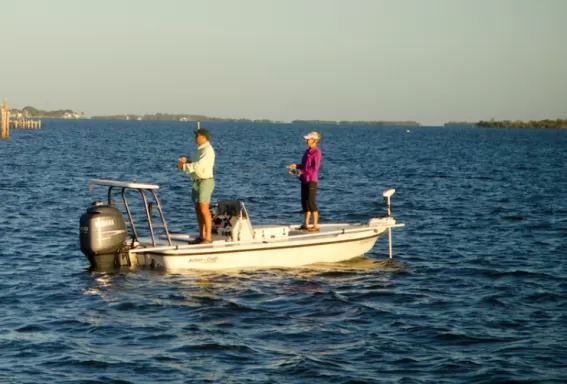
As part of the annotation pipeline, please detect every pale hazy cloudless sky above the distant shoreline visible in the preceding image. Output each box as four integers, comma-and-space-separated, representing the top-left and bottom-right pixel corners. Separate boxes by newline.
0, 0, 567, 125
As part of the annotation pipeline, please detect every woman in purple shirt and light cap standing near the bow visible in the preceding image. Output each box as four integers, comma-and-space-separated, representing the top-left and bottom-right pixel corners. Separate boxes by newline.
287, 132, 322, 232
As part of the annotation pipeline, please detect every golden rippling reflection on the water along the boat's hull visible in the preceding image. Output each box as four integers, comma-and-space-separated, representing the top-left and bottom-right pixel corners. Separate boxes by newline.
82, 256, 405, 307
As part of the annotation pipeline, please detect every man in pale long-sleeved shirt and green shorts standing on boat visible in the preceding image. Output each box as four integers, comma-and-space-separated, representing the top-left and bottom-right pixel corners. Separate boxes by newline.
177, 129, 215, 244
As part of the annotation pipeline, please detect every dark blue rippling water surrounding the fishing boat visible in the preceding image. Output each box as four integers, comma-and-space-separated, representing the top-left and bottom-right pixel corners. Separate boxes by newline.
0, 120, 567, 383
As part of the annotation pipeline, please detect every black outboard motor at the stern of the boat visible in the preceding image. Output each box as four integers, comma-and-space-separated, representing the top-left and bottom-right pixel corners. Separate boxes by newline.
80, 202, 128, 268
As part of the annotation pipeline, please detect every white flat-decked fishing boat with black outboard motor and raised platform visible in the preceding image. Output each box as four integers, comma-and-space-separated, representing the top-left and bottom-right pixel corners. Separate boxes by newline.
80, 180, 404, 269
